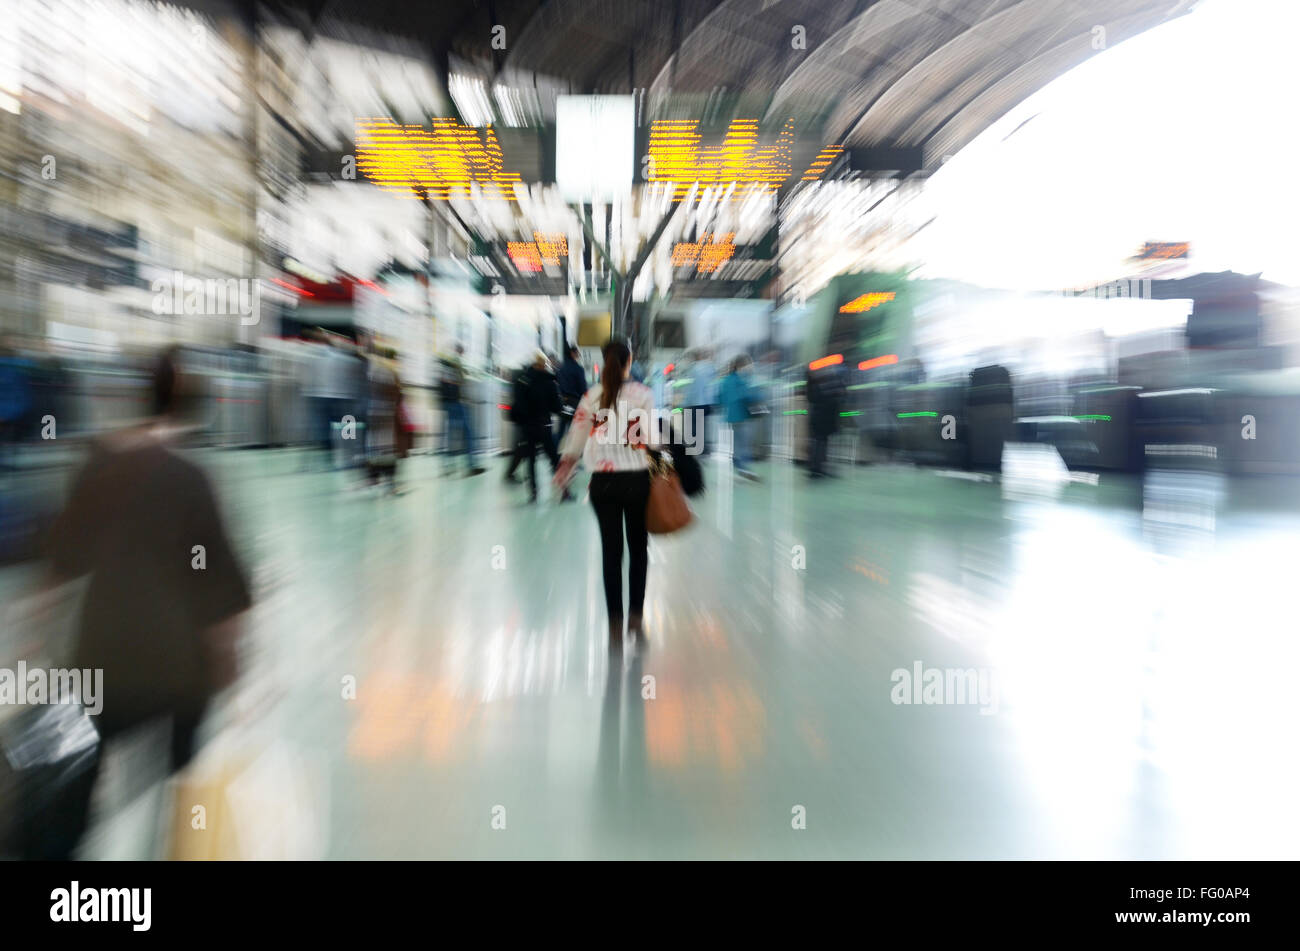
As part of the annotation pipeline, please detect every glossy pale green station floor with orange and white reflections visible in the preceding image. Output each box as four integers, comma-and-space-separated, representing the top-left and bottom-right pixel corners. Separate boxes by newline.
17, 452, 1300, 859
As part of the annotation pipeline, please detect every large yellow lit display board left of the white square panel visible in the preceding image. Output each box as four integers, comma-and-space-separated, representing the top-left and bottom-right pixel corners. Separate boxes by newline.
356, 118, 520, 201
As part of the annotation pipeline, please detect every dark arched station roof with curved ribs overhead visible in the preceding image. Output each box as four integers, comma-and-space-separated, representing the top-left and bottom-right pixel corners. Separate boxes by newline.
260, 0, 1188, 168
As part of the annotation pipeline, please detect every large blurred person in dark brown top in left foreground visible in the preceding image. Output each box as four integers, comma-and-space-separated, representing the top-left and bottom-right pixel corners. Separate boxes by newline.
40, 349, 252, 859
